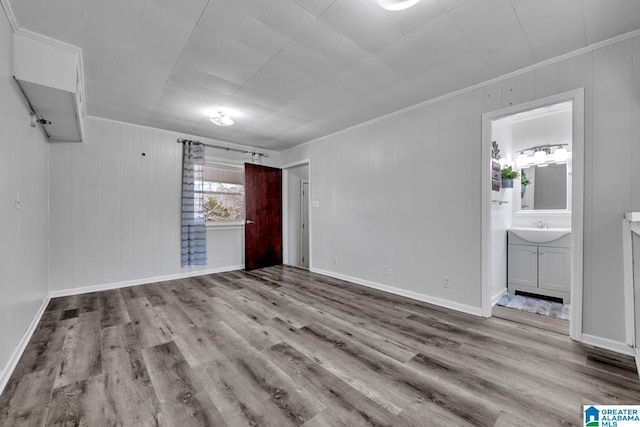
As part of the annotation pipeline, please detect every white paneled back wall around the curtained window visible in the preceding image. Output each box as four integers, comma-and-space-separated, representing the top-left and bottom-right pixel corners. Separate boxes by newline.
49, 118, 278, 292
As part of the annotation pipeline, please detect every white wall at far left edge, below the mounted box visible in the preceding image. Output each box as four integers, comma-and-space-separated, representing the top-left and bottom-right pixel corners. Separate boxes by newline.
0, 14, 49, 374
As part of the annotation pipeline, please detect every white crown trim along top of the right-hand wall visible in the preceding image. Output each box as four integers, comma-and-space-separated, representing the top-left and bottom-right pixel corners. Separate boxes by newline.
280, 29, 640, 157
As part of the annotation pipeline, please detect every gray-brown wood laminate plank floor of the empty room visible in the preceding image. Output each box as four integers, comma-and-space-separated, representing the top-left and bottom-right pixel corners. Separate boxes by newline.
0, 266, 640, 426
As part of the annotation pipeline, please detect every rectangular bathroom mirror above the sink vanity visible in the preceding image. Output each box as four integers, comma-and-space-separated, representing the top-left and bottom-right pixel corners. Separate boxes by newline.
520, 163, 569, 211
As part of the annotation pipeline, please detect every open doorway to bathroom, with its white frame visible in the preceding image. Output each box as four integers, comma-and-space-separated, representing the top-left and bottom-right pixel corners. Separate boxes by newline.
482, 90, 584, 339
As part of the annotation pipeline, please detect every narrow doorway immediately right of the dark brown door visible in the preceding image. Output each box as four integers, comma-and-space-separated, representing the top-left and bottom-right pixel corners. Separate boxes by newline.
282, 160, 311, 269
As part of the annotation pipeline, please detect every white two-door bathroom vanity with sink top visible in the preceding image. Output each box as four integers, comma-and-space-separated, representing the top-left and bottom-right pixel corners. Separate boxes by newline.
507, 228, 571, 304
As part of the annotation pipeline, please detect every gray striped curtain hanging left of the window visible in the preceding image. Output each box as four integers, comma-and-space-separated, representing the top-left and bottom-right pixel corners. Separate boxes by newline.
182, 141, 207, 267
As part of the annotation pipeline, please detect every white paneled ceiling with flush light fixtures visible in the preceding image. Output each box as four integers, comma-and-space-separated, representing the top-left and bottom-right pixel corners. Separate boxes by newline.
11, 0, 640, 150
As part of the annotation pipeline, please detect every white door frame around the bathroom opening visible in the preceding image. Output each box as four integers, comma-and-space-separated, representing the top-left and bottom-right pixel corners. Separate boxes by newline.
481, 88, 584, 341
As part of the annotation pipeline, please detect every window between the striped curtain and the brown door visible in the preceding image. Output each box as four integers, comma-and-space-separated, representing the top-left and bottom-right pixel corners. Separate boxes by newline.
202, 165, 244, 223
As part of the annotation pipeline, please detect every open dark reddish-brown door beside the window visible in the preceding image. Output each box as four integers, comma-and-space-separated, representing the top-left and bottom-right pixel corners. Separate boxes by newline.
244, 163, 282, 270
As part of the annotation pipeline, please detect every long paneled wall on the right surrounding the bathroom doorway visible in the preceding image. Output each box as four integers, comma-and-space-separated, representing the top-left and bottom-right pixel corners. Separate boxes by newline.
281, 37, 640, 342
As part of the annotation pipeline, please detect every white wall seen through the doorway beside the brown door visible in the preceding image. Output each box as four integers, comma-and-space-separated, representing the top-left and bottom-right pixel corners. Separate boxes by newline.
285, 165, 309, 267
